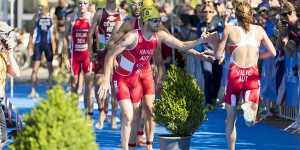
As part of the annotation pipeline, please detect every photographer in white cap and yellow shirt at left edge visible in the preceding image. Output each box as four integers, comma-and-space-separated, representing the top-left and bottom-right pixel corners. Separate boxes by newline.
0, 21, 20, 149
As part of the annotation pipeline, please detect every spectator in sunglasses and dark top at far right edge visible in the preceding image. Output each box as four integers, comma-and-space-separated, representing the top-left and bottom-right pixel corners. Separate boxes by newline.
276, 2, 300, 57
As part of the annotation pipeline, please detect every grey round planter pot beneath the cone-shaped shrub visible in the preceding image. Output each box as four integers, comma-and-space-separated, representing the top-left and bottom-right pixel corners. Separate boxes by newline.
156, 135, 193, 150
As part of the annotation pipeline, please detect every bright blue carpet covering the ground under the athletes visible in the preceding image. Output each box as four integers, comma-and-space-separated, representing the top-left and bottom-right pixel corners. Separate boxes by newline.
4, 85, 300, 150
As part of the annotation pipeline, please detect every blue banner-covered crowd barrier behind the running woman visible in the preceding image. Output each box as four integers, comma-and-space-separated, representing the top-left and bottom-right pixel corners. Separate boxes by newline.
187, 47, 300, 133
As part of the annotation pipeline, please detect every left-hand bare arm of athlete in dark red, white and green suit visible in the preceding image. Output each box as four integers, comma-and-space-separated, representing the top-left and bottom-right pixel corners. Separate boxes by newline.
88, 9, 102, 62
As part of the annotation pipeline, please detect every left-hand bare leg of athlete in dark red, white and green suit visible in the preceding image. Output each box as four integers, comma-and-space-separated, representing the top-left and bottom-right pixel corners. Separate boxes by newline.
95, 74, 109, 130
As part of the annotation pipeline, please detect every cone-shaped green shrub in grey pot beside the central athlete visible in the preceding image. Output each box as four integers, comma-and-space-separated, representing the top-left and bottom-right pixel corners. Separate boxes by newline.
153, 65, 206, 150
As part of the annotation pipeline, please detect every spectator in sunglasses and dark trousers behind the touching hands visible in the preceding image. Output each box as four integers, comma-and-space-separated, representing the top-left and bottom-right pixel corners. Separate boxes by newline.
196, 5, 222, 111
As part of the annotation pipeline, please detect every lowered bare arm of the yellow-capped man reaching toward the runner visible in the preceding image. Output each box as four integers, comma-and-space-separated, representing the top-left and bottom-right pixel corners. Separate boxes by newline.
98, 31, 137, 99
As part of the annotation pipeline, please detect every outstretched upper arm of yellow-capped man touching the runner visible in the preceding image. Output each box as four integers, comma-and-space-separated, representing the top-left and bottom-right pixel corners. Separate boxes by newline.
157, 31, 218, 51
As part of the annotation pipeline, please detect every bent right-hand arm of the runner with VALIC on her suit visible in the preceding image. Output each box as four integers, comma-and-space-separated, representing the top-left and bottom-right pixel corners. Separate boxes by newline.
258, 26, 276, 59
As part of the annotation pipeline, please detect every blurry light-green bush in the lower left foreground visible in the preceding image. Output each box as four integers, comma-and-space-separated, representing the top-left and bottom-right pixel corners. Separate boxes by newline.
9, 84, 98, 150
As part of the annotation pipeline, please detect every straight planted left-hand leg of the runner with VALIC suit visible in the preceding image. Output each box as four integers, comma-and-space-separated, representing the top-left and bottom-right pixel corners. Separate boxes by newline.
225, 103, 237, 150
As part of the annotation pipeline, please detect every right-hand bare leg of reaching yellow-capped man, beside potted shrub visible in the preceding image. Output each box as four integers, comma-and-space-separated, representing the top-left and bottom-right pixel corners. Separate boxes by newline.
143, 94, 155, 150
